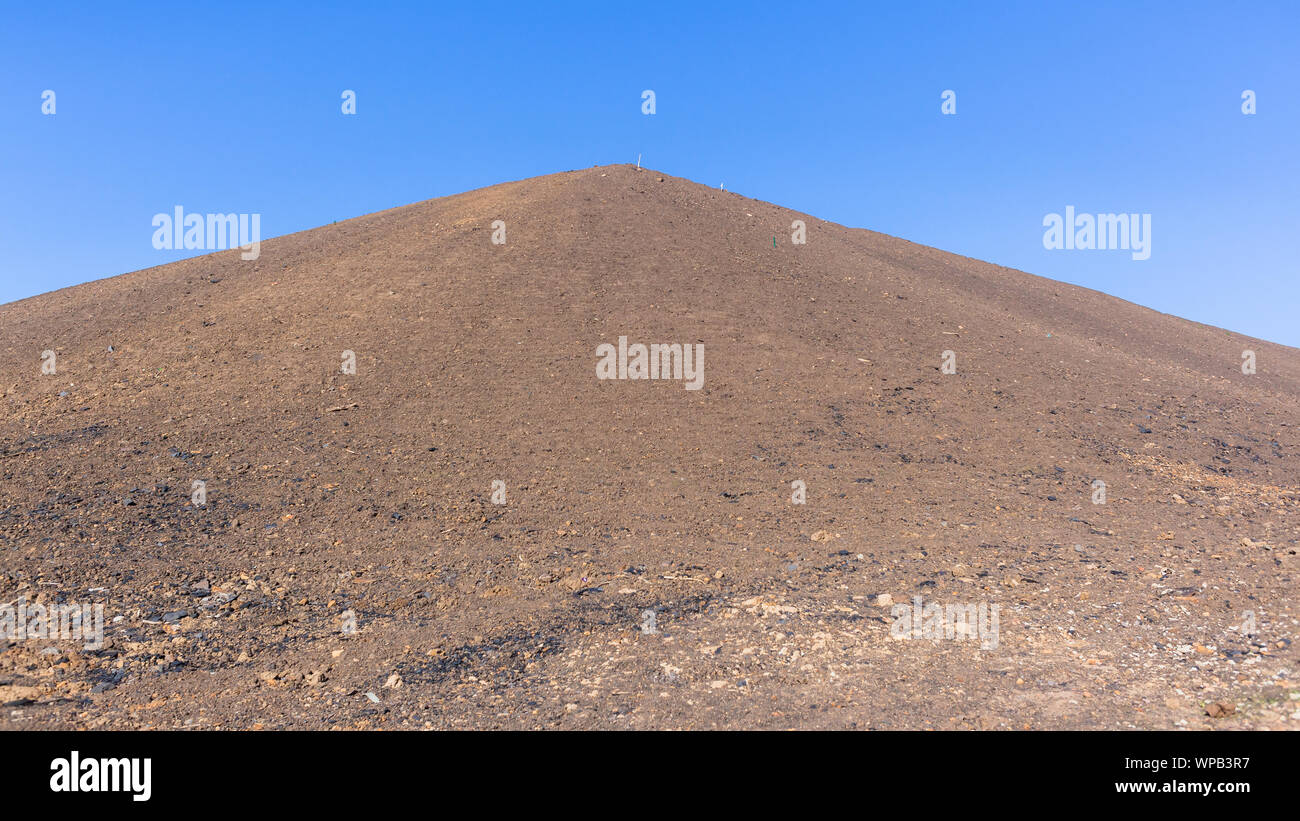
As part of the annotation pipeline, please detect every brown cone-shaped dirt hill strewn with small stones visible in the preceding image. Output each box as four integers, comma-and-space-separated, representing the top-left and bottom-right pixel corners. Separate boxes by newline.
0, 165, 1300, 729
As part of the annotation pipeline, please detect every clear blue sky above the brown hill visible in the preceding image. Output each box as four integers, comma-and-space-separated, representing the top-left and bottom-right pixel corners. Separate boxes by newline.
0, 1, 1300, 346
